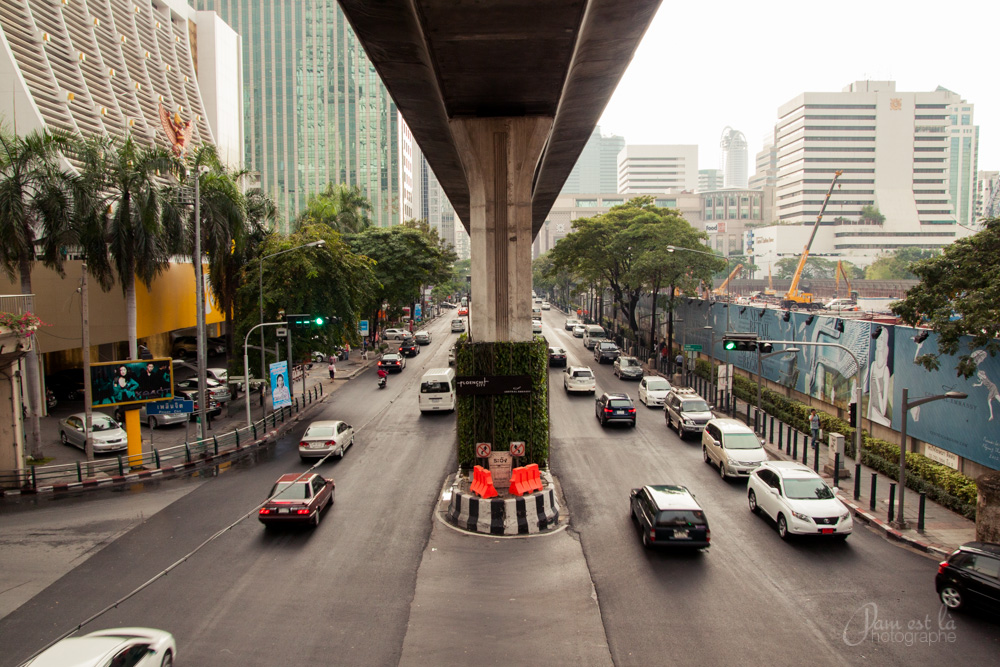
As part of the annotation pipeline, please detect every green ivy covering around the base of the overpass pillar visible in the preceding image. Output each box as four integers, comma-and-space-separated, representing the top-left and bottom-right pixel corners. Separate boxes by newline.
455, 338, 549, 470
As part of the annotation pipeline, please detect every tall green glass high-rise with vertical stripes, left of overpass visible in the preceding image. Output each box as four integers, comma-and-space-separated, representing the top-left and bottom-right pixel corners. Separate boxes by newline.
195, 0, 404, 230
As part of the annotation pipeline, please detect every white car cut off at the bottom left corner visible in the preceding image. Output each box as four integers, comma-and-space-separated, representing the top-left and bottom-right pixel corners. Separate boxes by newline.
24, 628, 177, 667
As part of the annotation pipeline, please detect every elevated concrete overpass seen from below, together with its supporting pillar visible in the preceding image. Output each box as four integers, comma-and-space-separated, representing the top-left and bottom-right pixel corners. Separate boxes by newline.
341, 0, 660, 341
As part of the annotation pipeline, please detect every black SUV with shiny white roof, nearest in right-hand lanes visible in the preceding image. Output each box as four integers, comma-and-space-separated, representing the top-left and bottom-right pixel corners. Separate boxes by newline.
629, 484, 712, 549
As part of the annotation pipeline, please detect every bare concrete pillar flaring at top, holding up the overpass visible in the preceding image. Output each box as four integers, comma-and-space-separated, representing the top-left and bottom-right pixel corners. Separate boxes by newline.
450, 116, 552, 342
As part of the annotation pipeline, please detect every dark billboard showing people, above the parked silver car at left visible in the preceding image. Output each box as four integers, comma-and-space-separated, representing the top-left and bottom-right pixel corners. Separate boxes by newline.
90, 359, 174, 408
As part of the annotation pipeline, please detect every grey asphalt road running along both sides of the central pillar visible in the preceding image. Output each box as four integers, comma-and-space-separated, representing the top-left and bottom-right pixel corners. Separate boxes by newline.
0, 311, 1000, 665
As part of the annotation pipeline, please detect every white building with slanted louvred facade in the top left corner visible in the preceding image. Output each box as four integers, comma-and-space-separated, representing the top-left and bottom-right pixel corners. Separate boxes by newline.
0, 0, 243, 162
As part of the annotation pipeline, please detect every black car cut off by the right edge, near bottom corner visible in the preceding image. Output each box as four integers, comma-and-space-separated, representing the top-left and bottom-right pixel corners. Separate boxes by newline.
934, 542, 1000, 613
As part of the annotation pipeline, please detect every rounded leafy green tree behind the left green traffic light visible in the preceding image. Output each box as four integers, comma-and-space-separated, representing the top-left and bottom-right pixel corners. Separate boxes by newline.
234, 224, 379, 370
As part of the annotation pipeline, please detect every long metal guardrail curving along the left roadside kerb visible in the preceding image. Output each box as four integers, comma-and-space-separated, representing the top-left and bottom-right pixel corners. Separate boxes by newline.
0, 396, 308, 490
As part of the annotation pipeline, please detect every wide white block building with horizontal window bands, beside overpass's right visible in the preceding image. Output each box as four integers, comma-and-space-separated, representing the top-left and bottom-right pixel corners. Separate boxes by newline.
618, 144, 698, 195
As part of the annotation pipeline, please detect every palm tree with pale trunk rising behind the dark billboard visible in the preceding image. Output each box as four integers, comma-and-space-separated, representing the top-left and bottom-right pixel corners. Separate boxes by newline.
80, 135, 179, 359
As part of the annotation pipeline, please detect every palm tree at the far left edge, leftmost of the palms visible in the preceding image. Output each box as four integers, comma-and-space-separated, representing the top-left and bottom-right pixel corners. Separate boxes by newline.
0, 128, 72, 459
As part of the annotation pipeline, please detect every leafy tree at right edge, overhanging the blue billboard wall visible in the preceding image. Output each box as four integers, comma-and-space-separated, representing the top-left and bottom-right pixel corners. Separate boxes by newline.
889, 218, 1000, 378
